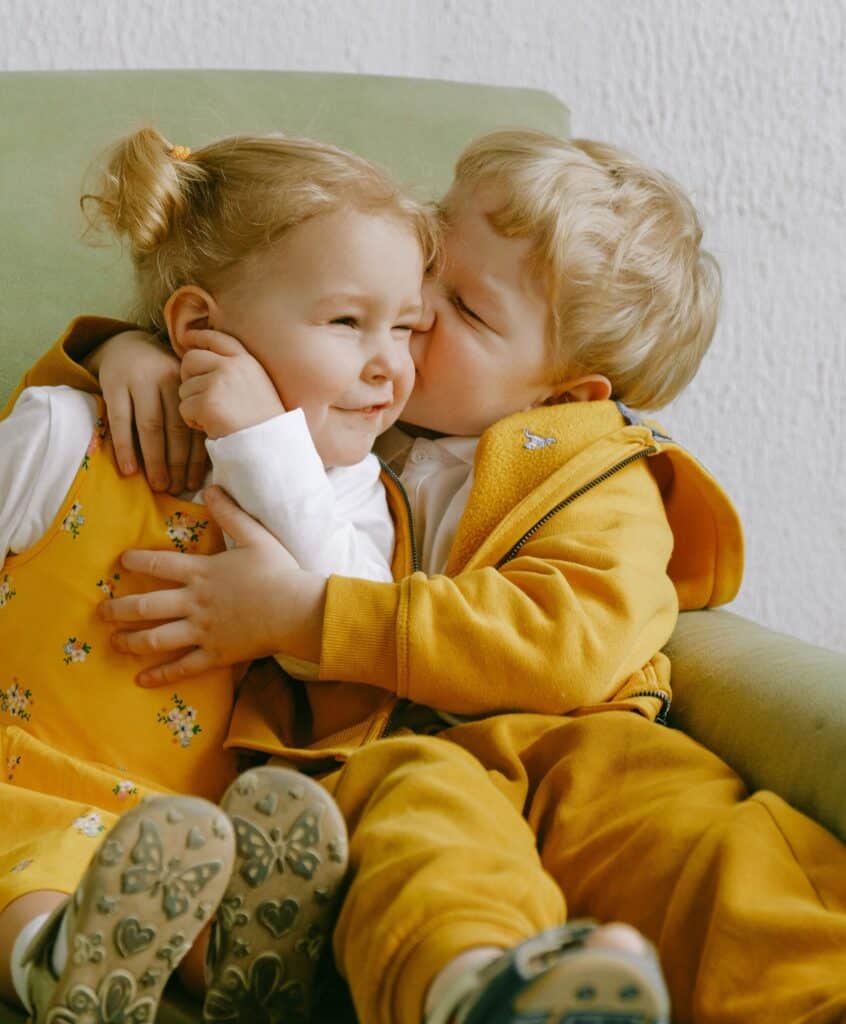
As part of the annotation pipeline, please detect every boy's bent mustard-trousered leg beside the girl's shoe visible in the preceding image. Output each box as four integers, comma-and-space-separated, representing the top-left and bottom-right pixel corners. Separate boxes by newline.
326, 736, 660, 1024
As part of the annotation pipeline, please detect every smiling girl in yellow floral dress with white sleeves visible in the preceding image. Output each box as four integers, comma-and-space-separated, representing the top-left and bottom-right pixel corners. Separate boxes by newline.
0, 123, 435, 1021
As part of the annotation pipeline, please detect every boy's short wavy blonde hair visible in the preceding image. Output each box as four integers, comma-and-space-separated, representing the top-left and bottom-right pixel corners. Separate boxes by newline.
443, 130, 720, 410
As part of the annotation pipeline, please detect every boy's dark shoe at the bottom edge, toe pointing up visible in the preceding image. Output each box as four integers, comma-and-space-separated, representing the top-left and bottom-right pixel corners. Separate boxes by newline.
426, 922, 670, 1024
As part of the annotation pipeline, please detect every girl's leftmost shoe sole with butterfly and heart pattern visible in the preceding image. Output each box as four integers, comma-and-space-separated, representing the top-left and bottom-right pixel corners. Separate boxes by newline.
42, 797, 235, 1024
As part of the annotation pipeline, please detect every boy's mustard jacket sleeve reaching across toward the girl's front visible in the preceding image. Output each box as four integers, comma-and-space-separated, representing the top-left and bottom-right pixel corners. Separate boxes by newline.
321, 460, 678, 715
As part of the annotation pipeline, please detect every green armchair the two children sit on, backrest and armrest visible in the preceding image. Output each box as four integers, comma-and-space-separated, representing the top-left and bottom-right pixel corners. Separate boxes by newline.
0, 71, 846, 1024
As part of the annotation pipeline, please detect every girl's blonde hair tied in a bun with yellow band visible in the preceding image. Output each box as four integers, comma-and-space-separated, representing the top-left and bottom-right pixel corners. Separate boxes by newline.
80, 128, 437, 331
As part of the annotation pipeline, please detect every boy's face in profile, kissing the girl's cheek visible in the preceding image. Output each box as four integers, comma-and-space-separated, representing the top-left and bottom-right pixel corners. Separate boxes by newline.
401, 186, 553, 436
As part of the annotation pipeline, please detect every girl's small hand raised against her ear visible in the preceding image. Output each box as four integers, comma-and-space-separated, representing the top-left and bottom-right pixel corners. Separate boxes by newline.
179, 330, 285, 438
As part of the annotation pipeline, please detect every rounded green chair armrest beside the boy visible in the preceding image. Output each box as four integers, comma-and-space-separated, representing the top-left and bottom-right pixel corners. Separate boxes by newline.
666, 610, 846, 840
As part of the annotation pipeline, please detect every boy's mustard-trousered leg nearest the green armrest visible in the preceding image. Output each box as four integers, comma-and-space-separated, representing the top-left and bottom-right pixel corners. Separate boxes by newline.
450, 712, 846, 1024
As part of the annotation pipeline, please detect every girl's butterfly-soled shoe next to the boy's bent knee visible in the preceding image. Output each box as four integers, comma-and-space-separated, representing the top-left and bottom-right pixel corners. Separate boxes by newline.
203, 765, 347, 1024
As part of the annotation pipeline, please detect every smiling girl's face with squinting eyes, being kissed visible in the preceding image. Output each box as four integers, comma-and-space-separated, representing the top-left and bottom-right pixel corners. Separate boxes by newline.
209, 209, 423, 466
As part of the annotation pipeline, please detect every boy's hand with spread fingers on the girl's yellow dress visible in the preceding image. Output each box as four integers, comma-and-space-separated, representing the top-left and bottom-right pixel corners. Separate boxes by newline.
99, 487, 326, 686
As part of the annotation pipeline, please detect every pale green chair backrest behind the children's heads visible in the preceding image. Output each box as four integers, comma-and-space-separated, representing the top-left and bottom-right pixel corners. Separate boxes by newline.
0, 71, 568, 403
